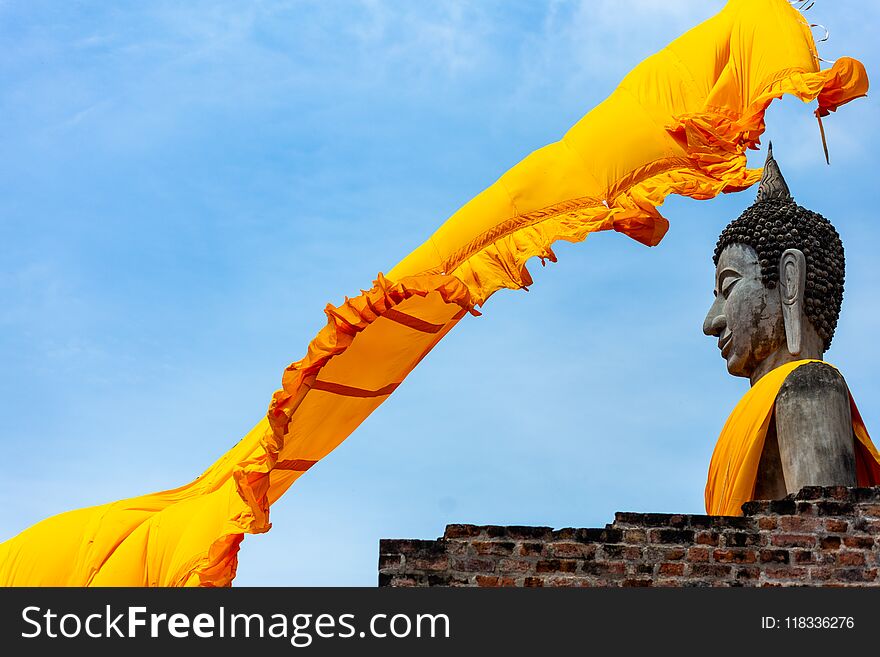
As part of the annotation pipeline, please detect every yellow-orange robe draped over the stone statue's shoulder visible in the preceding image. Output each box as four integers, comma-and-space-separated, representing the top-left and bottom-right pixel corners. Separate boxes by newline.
706, 360, 880, 516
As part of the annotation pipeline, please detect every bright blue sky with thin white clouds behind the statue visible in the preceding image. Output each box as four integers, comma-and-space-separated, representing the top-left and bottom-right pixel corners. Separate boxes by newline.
0, 0, 880, 586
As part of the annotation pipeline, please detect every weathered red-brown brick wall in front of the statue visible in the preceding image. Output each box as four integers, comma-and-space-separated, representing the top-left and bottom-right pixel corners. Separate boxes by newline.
379, 487, 880, 586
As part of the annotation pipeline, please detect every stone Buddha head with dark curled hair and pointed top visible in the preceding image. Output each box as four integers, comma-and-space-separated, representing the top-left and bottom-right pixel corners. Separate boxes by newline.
703, 145, 844, 384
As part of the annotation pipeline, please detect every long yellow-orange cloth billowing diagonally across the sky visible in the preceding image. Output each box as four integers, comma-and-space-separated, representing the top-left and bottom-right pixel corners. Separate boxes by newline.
0, 0, 868, 586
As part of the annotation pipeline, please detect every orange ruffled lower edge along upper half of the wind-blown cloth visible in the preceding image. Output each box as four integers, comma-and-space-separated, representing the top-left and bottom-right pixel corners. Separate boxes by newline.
434, 57, 868, 305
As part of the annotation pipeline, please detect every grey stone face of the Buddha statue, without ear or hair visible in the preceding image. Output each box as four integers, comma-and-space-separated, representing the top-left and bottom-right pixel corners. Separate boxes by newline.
703, 244, 785, 377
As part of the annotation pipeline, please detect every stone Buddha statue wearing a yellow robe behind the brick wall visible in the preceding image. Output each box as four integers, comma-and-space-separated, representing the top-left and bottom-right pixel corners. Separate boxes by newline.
703, 146, 880, 515
